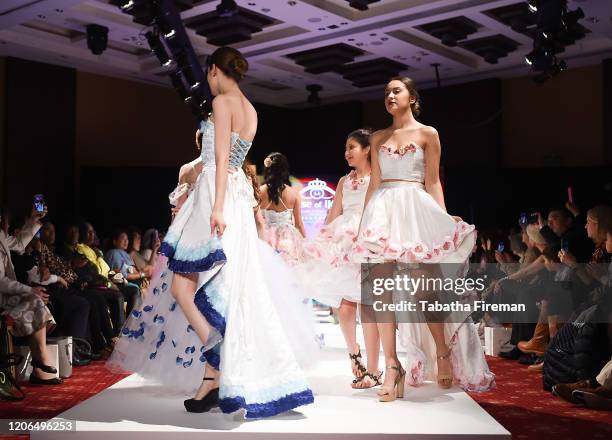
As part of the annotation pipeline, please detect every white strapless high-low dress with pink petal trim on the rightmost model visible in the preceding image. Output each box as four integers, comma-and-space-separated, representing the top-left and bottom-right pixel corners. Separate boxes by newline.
353, 143, 495, 391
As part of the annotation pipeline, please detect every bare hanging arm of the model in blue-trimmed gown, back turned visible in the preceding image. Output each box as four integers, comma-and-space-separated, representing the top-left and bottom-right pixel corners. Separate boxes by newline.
210, 95, 232, 236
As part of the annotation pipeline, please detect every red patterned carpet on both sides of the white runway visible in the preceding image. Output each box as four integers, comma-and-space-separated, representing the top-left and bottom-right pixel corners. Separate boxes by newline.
0, 357, 612, 440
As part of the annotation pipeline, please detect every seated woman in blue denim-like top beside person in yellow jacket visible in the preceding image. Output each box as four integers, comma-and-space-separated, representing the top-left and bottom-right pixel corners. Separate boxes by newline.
104, 230, 146, 314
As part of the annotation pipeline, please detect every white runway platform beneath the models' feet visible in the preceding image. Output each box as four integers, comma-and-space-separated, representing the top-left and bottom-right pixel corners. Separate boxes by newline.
31, 324, 511, 440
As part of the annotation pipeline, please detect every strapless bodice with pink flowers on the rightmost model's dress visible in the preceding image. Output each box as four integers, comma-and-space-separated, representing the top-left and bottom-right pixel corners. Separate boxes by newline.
378, 142, 425, 183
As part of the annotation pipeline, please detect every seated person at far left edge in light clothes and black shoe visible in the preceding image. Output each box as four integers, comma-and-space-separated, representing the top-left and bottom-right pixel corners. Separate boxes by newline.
0, 205, 62, 385
